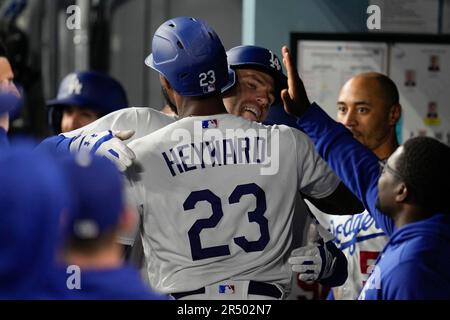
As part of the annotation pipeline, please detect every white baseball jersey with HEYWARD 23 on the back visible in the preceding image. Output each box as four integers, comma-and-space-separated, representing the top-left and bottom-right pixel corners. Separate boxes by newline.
123, 114, 339, 293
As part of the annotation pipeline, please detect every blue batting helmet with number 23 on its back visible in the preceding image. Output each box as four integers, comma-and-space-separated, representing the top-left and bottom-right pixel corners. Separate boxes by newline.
145, 17, 228, 97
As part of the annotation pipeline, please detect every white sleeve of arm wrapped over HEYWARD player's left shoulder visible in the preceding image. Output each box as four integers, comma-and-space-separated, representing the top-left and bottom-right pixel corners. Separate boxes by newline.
64, 107, 175, 144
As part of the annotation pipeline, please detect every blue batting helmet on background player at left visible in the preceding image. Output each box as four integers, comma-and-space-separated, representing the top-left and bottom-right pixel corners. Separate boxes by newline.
47, 71, 128, 133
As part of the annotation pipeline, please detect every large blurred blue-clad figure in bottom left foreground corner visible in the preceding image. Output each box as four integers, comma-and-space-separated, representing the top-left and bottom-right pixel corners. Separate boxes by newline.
0, 144, 71, 299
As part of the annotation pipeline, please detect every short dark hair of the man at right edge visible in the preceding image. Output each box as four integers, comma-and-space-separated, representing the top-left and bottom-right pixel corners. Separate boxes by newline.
397, 137, 450, 213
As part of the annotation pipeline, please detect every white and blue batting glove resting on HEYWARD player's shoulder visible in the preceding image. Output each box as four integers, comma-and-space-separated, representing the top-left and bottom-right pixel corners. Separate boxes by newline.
70, 130, 136, 172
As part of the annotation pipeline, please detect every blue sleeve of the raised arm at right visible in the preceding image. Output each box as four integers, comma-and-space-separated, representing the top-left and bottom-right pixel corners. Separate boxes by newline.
297, 104, 394, 236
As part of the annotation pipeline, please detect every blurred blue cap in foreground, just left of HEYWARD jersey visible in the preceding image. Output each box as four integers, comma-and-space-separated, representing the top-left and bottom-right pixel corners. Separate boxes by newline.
61, 152, 124, 240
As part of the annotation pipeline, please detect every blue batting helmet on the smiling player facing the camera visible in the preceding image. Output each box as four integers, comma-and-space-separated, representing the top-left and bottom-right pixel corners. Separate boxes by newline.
224, 45, 287, 99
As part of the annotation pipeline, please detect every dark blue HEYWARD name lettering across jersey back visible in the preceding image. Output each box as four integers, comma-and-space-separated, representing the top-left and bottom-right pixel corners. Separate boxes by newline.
162, 121, 279, 176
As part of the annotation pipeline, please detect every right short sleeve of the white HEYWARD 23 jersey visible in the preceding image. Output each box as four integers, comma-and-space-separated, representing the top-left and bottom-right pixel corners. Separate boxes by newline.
291, 130, 340, 199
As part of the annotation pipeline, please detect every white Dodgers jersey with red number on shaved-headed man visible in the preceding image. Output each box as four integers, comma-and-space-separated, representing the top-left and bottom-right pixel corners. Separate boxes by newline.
310, 205, 388, 300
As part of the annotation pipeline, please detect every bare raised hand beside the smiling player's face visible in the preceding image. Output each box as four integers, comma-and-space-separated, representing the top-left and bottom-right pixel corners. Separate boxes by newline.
281, 47, 311, 117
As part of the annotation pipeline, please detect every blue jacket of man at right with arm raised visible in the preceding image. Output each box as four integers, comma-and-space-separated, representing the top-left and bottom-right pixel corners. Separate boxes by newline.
297, 104, 450, 300
